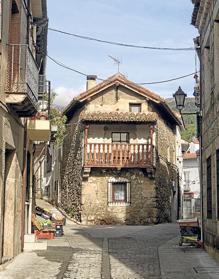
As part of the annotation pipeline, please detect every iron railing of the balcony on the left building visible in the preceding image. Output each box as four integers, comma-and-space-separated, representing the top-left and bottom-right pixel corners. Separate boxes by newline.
6, 44, 39, 105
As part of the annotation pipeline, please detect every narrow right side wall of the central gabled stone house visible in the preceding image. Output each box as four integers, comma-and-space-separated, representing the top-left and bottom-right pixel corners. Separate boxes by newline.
155, 119, 179, 222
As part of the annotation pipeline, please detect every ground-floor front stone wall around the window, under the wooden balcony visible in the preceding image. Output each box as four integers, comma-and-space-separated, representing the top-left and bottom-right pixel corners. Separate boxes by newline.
82, 169, 157, 224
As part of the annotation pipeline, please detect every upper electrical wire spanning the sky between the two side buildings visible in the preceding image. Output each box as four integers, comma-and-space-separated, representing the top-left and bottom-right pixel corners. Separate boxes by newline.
48, 28, 195, 51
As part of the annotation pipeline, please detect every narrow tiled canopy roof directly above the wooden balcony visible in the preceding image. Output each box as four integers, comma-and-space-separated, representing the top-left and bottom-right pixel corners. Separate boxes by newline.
80, 112, 157, 123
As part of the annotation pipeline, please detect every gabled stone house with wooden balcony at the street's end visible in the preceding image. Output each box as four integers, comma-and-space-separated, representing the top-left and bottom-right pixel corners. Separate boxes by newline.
61, 73, 180, 224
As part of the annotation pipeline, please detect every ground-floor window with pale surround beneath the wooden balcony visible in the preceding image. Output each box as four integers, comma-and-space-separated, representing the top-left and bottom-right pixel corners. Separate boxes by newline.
108, 178, 130, 205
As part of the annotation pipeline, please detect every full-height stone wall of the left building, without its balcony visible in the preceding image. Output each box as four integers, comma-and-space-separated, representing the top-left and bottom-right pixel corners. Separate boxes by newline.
0, 1, 24, 264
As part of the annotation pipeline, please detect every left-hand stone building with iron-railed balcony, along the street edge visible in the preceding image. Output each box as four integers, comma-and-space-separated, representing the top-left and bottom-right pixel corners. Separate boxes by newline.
0, 0, 50, 264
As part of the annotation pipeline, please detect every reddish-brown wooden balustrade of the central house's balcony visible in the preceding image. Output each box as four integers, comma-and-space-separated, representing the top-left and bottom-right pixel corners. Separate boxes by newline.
84, 143, 154, 168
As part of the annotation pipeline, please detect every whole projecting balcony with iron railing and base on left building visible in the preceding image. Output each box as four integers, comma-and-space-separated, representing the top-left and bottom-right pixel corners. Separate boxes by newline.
6, 44, 39, 117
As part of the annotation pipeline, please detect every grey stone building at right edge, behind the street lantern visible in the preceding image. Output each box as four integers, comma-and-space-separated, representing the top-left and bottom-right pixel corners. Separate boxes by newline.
192, 0, 219, 259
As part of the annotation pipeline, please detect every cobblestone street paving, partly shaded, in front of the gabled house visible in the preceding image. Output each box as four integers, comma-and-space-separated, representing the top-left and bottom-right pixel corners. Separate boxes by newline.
0, 224, 219, 279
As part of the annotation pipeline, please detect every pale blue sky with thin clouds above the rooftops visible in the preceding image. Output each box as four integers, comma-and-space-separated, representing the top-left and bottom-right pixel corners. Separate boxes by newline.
47, 0, 197, 106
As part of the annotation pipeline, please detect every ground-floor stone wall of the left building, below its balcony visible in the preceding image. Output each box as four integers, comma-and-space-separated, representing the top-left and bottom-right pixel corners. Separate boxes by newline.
1, 113, 24, 259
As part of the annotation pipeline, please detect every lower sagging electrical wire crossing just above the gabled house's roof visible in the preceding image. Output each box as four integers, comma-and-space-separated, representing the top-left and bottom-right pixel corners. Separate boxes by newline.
47, 54, 196, 85
